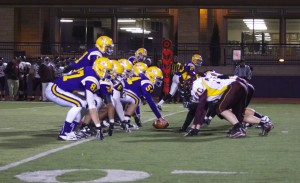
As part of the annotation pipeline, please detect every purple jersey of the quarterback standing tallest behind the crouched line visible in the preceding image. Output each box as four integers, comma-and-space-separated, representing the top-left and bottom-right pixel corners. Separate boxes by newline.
70, 47, 102, 70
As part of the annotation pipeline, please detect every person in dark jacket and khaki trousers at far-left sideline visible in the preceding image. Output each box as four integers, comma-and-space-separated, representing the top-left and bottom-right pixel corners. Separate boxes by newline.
4, 58, 19, 100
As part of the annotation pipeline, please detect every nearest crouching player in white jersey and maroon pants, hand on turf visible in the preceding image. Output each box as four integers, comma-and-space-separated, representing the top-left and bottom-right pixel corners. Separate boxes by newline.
186, 78, 273, 138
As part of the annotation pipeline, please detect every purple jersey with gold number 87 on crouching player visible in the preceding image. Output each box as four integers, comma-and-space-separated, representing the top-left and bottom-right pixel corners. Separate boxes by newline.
53, 66, 100, 93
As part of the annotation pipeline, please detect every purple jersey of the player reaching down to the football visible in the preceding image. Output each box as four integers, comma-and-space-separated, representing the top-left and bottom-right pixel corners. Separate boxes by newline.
124, 74, 161, 118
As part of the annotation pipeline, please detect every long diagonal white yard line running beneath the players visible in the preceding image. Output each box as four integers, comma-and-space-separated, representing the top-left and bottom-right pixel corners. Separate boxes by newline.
0, 110, 186, 171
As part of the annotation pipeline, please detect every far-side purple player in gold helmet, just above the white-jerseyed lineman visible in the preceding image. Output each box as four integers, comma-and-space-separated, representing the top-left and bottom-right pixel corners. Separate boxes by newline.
157, 54, 203, 110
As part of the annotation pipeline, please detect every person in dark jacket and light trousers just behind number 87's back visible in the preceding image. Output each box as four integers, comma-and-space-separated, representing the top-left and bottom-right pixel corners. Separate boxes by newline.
39, 57, 55, 102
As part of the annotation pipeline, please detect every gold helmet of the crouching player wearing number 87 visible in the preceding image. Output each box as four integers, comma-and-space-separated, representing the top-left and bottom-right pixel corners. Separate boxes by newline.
93, 57, 113, 79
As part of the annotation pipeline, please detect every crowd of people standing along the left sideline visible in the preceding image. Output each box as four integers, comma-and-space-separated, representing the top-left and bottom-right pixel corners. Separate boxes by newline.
0, 56, 75, 101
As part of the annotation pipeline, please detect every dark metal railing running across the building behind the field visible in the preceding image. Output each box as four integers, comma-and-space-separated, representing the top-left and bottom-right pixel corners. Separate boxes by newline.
0, 42, 300, 66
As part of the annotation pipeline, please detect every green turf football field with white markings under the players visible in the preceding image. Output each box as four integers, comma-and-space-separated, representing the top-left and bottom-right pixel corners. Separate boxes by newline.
0, 102, 300, 183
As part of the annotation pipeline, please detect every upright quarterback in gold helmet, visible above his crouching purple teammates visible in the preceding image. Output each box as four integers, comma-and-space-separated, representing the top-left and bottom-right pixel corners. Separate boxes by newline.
63, 36, 114, 73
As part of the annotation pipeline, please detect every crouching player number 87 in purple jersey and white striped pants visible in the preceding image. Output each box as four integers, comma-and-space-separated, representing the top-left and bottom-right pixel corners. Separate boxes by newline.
46, 57, 113, 141
